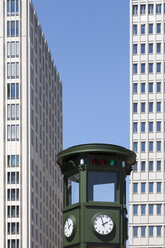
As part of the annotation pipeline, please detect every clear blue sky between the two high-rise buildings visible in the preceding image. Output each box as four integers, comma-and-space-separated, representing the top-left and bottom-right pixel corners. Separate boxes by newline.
33, 0, 129, 149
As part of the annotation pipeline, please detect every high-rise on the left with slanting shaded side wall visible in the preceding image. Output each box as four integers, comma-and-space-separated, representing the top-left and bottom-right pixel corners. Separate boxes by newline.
0, 0, 62, 248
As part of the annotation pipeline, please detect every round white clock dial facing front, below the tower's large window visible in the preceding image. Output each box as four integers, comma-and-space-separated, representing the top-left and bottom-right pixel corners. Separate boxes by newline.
93, 214, 114, 235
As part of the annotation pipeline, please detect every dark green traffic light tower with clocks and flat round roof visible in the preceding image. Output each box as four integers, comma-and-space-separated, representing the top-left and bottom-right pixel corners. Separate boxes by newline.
57, 144, 136, 248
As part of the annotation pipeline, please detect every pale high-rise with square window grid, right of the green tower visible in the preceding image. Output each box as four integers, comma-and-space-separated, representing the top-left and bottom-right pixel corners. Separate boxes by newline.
129, 0, 165, 248
